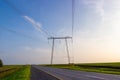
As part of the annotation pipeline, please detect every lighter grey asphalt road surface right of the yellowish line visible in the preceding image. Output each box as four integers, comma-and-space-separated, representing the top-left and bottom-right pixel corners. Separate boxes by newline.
33, 66, 120, 80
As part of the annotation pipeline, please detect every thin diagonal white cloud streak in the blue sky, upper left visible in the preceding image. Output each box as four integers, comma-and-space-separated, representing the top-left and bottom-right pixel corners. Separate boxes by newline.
23, 16, 42, 32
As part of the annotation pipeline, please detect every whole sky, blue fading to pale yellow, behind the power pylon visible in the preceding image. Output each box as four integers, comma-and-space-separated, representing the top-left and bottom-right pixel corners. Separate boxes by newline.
0, 0, 120, 64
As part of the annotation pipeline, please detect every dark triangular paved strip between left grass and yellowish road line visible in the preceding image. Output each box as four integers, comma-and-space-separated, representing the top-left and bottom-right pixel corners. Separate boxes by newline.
31, 66, 59, 80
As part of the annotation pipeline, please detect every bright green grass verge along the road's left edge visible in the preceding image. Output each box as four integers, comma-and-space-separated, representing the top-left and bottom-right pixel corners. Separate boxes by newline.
0, 66, 30, 80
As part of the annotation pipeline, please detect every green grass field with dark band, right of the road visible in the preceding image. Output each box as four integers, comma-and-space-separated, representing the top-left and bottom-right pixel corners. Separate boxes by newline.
46, 63, 120, 75
